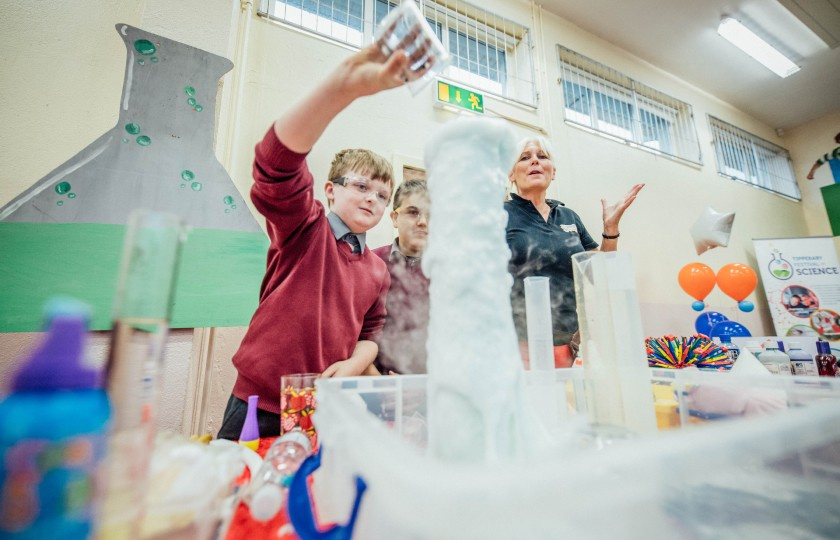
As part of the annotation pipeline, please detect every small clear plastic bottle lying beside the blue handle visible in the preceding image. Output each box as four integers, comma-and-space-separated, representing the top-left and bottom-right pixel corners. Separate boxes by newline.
245, 430, 312, 521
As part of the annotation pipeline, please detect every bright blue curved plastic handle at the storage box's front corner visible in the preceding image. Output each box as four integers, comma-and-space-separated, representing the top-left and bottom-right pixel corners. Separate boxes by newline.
288, 446, 367, 540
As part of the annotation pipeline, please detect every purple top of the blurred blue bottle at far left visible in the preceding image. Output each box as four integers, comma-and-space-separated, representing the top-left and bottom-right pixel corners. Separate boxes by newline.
12, 299, 102, 391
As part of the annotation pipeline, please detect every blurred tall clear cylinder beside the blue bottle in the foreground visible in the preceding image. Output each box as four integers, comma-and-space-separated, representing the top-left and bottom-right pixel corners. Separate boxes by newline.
99, 210, 185, 538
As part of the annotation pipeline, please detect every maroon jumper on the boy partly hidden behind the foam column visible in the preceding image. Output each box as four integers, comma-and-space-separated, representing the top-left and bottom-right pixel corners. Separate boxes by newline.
373, 240, 429, 375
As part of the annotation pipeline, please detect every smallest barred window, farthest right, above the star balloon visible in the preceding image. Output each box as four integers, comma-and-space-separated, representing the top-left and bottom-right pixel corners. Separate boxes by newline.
709, 116, 802, 201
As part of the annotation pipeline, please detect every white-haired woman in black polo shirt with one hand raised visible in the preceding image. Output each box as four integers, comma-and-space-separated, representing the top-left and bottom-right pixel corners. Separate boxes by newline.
505, 137, 644, 367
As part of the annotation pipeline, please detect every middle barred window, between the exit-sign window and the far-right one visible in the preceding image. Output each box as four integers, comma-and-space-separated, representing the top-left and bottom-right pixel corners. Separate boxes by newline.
557, 45, 702, 164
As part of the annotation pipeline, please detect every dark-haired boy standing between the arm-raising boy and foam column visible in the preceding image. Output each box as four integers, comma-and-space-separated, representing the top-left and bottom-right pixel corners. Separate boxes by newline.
373, 180, 429, 374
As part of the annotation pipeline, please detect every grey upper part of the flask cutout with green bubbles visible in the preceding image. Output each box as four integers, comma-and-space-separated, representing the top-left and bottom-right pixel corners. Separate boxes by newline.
0, 24, 260, 232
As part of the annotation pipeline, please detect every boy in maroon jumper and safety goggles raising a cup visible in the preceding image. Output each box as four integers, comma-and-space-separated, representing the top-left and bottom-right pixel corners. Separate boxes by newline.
218, 34, 425, 439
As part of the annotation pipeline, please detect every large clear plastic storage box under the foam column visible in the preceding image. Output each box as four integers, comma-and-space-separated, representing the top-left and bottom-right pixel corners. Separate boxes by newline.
300, 369, 840, 539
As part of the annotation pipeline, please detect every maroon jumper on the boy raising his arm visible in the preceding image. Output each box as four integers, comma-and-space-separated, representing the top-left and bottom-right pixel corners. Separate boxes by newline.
232, 127, 390, 414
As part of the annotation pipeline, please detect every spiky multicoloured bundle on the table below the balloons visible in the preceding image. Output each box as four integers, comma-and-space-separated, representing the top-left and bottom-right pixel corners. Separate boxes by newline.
645, 334, 732, 369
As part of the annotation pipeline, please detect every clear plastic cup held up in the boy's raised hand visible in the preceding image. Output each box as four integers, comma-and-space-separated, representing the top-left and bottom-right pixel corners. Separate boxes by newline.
374, 0, 450, 96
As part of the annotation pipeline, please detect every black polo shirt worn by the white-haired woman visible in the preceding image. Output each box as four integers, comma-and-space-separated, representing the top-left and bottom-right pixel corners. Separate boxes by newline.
505, 194, 598, 345
